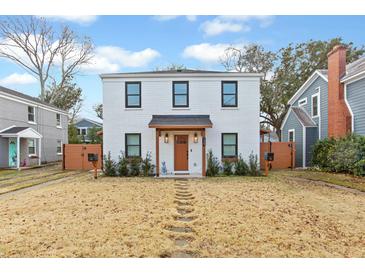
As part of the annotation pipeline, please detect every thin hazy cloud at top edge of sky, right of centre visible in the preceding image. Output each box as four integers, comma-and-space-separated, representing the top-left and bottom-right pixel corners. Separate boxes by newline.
200, 15, 274, 36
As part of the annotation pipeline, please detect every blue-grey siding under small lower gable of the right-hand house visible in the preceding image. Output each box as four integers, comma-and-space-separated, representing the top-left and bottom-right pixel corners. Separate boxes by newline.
282, 111, 303, 167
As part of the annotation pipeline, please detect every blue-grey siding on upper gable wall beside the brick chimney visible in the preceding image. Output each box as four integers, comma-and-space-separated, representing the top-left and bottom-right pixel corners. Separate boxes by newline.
293, 77, 328, 139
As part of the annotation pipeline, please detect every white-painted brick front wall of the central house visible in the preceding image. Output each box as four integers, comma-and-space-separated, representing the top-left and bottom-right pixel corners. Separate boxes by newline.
103, 74, 260, 173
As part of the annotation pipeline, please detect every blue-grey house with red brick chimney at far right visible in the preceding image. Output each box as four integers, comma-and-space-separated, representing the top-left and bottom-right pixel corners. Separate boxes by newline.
281, 45, 365, 167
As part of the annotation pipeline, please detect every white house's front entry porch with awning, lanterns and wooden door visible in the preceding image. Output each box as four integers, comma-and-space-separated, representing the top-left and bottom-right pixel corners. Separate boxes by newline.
149, 115, 213, 177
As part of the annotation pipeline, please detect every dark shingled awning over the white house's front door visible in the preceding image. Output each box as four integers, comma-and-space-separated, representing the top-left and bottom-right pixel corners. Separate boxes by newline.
148, 115, 213, 129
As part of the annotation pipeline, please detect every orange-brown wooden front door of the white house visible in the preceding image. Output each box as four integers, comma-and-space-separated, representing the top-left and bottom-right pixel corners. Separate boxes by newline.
174, 135, 189, 171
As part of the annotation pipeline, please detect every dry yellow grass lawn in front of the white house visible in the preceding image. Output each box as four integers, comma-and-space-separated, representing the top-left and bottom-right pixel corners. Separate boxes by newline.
0, 173, 365, 257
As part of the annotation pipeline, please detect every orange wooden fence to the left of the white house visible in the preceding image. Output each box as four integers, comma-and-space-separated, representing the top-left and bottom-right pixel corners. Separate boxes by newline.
63, 144, 103, 170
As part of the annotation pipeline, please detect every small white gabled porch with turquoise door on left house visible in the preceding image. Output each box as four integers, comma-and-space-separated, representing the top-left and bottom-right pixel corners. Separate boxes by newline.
0, 126, 42, 169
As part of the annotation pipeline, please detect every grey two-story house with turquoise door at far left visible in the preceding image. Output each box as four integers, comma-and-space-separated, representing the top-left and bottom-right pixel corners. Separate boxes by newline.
0, 87, 68, 169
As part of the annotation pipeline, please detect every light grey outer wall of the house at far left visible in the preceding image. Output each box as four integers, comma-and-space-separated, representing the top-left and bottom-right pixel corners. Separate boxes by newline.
0, 97, 68, 167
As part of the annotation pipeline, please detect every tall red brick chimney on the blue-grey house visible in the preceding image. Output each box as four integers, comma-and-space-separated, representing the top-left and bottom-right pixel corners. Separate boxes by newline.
327, 45, 351, 138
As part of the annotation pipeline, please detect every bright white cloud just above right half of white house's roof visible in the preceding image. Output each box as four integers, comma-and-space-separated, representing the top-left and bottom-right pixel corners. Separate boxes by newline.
183, 43, 242, 64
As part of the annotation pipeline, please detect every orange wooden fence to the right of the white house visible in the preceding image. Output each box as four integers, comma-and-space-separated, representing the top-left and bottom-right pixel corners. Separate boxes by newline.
260, 142, 295, 169
